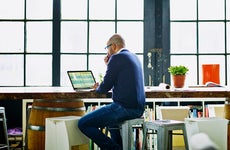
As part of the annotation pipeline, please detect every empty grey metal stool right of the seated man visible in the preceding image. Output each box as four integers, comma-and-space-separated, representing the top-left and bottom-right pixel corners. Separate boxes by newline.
142, 120, 188, 150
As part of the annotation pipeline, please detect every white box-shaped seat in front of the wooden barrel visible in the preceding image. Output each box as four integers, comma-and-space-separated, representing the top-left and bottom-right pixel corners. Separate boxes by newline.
45, 116, 89, 150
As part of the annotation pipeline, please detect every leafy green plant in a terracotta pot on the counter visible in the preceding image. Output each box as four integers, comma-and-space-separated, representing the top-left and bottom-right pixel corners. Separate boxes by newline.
168, 65, 189, 88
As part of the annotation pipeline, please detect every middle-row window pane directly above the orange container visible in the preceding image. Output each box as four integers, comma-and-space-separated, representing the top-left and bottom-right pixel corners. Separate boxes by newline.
199, 22, 225, 53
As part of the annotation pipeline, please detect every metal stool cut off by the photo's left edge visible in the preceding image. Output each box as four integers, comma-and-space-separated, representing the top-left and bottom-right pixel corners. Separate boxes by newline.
0, 107, 10, 150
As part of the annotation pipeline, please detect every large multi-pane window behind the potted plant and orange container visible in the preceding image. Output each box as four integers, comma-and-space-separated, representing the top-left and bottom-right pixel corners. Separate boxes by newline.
170, 0, 230, 85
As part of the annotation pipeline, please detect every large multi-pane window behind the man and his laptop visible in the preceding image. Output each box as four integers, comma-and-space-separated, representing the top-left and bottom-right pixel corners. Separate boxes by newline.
0, 0, 144, 86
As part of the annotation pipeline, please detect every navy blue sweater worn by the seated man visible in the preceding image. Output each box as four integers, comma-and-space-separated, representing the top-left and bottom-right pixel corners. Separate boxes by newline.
96, 49, 145, 109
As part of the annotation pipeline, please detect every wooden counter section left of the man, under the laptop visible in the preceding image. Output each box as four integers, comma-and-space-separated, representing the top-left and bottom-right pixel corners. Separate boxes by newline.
0, 87, 106, 100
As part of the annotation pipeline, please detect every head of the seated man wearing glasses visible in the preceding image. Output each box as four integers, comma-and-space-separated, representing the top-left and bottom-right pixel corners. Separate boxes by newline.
107, 34, 125, 55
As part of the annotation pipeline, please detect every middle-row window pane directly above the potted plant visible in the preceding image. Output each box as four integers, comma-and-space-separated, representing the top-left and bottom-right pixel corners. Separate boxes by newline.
171, 23, 196, 53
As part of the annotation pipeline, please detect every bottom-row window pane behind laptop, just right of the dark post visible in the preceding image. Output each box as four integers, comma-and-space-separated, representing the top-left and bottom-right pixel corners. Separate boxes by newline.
61, 55, 87, 86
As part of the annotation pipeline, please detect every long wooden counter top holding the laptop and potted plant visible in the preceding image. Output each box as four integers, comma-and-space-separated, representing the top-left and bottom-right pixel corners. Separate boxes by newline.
0, 87, 230, 100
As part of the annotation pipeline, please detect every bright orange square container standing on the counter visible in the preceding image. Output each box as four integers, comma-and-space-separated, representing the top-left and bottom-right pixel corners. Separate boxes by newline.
202, 64, 220, 84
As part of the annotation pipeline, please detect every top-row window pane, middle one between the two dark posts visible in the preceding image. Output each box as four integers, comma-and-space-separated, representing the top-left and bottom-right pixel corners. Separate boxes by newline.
89, 0, 115, 19
